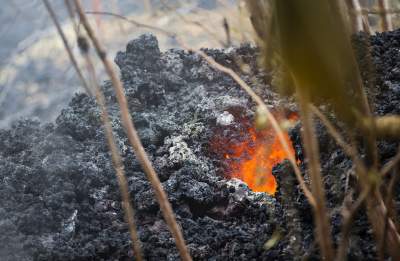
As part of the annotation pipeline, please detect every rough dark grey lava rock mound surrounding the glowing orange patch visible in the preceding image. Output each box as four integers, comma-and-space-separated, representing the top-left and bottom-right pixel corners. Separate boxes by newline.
0, 31, 400, 260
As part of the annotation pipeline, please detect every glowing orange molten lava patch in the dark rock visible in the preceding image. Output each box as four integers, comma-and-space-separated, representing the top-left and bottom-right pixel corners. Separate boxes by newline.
211, 110, 298, 195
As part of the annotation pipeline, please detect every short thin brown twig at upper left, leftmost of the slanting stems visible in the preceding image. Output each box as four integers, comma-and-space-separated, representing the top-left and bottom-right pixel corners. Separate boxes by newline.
42, 0, 93, 95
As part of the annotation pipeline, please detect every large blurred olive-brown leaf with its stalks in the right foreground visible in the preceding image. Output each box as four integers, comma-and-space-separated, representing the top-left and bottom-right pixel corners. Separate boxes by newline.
246, 0, 400, 260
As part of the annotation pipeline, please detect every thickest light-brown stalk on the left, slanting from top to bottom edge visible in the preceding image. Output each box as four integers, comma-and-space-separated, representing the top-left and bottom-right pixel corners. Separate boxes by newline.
74, 0, 192, 261
